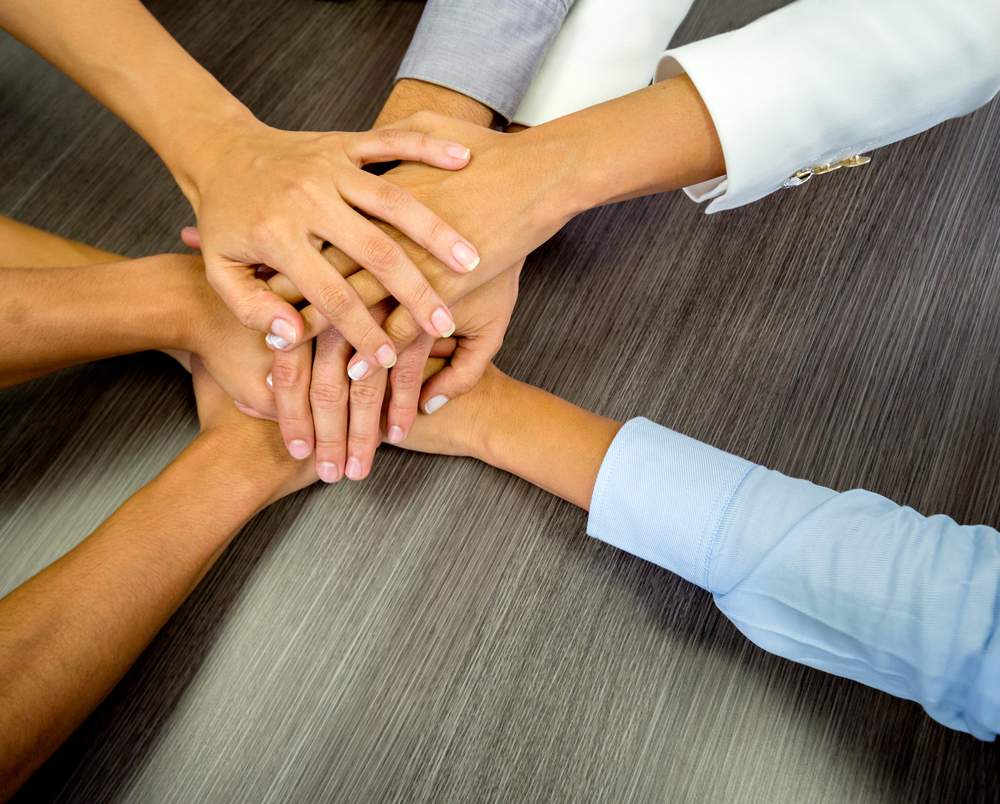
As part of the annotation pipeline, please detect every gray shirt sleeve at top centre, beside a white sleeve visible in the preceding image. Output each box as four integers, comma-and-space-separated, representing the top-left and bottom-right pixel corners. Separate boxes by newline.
396, 0, 573, 120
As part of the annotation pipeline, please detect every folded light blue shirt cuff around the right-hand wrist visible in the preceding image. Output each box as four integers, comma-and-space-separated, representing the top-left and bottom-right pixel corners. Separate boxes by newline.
587, 419, 756, 589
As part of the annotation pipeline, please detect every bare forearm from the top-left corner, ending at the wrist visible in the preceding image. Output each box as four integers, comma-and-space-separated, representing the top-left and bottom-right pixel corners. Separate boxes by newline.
0, 0, 253, 198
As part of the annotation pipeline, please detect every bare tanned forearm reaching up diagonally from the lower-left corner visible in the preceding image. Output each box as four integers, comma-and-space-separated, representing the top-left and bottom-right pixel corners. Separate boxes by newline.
0, 422, 296, 800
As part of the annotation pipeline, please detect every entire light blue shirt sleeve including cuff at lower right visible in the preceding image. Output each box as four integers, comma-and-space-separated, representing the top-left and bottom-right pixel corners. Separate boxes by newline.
587, 419, 1000, 740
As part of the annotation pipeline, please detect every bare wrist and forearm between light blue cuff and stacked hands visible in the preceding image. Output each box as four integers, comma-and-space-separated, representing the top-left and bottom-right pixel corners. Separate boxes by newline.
472, 373, 622, 510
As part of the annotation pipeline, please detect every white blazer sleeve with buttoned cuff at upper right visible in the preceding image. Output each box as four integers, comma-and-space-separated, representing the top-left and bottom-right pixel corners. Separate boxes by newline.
656, 0, 1000, 212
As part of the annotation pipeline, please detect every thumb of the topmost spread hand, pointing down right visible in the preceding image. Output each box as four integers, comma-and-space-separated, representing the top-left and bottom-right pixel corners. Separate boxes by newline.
205, 255, 304, 349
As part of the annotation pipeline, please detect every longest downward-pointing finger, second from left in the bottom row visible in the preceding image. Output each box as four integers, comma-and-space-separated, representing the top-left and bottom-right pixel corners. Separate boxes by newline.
309, 329, 353, 483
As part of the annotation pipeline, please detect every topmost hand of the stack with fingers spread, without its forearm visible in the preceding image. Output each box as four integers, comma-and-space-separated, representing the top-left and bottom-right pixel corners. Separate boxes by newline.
188, 120, 479, 366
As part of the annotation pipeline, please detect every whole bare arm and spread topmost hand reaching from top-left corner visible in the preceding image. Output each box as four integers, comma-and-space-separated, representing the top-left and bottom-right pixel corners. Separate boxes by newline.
0, 0, 478, 365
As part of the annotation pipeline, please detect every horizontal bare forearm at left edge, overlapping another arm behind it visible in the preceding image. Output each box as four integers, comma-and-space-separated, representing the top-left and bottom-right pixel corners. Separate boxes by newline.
0, 255, 203, 388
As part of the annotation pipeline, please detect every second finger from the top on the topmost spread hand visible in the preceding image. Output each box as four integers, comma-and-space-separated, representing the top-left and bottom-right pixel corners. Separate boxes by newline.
345, 168, 479, 274
